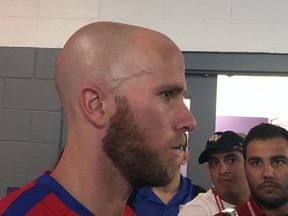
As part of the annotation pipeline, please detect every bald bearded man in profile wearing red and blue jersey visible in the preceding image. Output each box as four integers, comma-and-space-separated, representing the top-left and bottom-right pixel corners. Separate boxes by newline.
0, 22, 196, 216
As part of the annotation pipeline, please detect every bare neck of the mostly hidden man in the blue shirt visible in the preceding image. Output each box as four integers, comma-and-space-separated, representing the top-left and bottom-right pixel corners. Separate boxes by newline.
151, 173, 180, 205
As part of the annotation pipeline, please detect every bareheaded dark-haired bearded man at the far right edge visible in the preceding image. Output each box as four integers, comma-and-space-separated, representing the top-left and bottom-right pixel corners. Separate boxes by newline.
225, 123, 288, 216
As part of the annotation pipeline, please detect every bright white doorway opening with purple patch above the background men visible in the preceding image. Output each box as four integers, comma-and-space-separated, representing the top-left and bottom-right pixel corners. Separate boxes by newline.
215, 75, 288, 134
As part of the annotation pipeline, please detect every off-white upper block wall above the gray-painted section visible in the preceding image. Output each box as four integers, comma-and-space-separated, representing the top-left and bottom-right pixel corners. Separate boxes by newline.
0, 0, 288, 53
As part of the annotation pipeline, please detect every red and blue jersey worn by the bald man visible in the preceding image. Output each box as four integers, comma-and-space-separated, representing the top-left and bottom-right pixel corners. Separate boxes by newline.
0, 171, 134, 216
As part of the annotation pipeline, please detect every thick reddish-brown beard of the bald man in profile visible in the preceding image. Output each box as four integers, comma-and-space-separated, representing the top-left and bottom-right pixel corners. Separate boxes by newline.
103, 97, 179, 188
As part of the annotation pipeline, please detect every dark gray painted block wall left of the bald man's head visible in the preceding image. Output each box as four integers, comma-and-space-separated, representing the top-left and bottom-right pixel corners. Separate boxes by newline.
0, 47, 61, 198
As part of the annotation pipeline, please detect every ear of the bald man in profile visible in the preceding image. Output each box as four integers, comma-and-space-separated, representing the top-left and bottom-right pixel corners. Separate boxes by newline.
82, 88, 107, 128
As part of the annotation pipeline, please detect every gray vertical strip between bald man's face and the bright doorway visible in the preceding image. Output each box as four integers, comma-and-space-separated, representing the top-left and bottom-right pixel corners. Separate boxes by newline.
186, 75, 217, 189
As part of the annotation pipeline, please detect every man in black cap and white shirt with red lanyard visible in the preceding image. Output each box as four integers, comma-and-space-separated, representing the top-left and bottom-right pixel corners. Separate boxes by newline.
178, 131, 250, 216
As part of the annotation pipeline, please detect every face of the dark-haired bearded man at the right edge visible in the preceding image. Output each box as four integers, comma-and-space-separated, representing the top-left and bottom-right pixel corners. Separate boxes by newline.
245, 138, 288, 208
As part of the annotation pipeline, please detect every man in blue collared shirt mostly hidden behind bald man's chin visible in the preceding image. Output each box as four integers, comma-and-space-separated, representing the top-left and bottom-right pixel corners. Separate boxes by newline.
128, 135, 206, 216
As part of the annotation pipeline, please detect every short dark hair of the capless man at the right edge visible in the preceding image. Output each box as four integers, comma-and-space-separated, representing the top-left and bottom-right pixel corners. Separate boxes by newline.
243, 123, 288, 158
